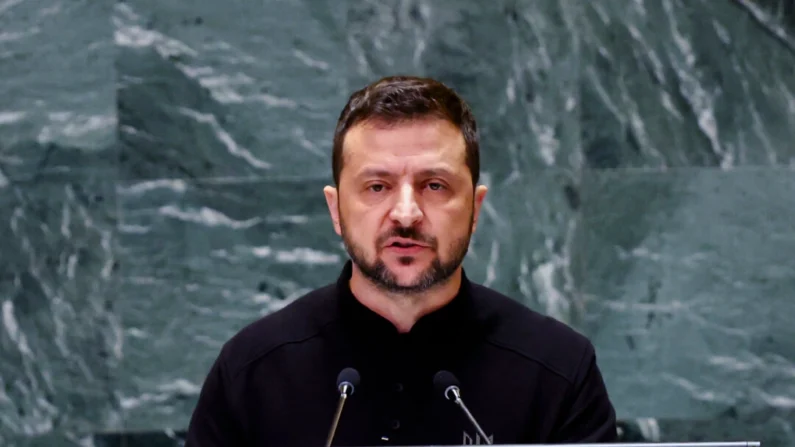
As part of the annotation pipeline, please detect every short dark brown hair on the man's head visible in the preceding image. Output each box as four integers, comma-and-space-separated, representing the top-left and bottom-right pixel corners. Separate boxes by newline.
331, 76, 480, 187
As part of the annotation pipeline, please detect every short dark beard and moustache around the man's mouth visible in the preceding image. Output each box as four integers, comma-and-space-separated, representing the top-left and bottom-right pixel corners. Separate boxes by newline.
340, 214, 474, 295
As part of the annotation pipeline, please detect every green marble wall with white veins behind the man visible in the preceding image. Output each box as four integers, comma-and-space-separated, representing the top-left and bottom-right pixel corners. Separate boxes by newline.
0, 0, 795, 447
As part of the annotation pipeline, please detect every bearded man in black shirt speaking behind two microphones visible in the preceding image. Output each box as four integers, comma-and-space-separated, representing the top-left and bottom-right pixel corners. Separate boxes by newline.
187, 77, 616, 447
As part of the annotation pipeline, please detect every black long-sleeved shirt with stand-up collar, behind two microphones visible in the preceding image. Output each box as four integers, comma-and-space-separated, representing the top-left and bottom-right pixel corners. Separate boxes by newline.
186, 261, 617, 447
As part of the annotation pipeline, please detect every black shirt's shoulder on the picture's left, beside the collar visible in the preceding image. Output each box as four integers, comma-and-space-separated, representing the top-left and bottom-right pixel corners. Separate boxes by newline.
215, 284, 336, 375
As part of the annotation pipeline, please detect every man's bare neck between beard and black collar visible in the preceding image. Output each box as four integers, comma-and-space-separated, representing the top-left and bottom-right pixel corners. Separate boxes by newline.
349, 266, 462, 333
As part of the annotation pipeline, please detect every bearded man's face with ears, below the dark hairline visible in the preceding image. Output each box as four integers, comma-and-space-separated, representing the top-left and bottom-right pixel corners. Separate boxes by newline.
325, 119, 486, 294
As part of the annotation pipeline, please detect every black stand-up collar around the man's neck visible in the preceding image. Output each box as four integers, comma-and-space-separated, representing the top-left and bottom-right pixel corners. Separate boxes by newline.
337, 260, 475, 342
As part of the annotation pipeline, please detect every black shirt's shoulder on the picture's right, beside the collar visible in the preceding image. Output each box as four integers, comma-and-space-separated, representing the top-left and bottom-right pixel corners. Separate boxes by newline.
473, 284, 594, 382
